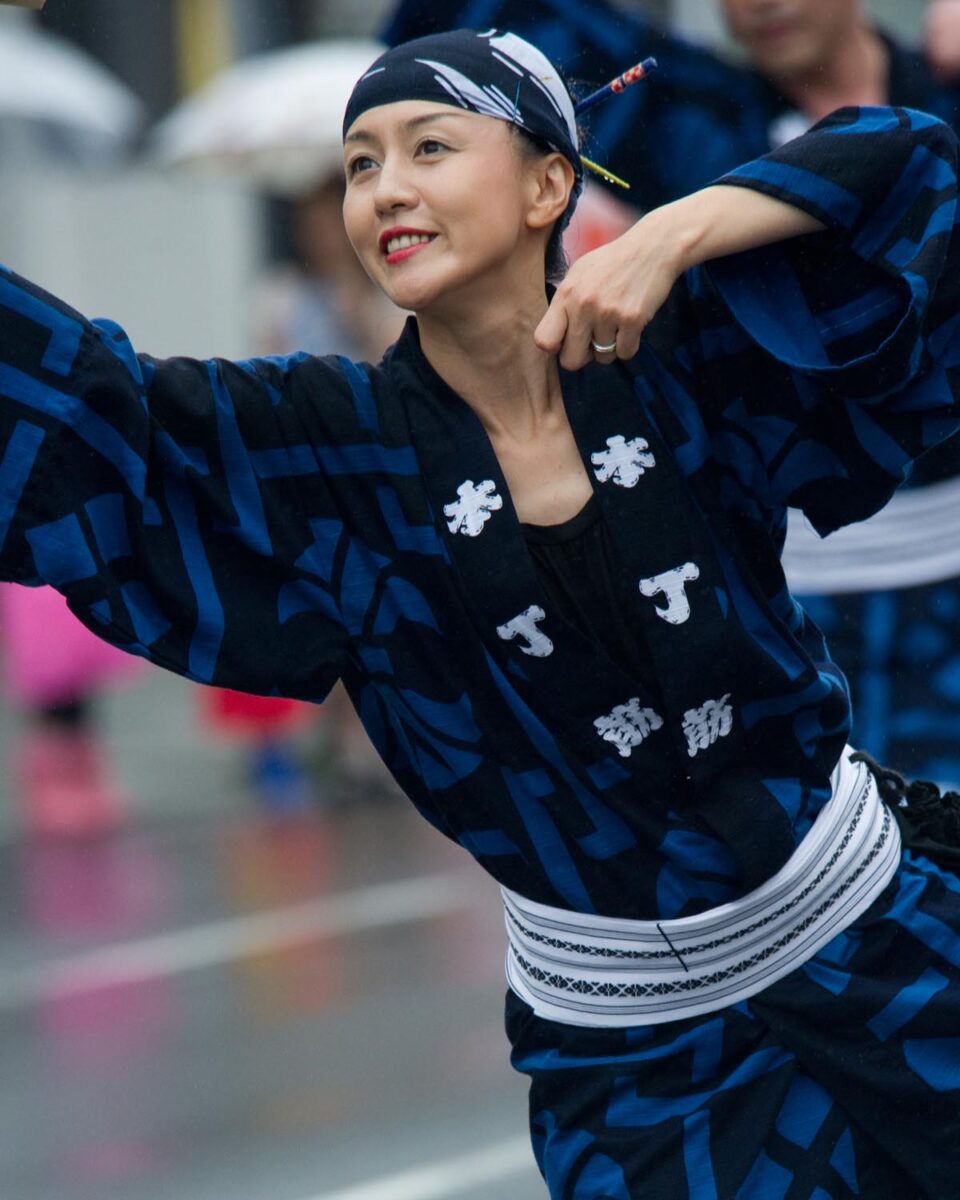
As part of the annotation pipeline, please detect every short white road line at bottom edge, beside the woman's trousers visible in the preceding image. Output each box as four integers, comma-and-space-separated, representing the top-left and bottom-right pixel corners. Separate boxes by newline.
300, 1138, 536, 1200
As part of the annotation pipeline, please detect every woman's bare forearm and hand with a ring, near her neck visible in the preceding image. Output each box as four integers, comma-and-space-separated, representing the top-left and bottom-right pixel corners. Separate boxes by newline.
536, 185, 824, 371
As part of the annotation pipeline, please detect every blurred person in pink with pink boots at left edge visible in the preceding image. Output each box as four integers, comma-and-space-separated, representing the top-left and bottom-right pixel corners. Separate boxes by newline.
0, 584, 146, 838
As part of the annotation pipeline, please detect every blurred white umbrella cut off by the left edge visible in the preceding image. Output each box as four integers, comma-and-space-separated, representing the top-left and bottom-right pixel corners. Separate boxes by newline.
0, 12, 143, 162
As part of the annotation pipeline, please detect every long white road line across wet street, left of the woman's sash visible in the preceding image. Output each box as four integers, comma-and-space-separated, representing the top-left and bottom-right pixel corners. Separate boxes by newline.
0, 871, 482, 1012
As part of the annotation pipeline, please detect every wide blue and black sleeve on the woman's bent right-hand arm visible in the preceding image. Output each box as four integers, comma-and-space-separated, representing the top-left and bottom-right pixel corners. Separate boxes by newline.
688, 108, 960, 534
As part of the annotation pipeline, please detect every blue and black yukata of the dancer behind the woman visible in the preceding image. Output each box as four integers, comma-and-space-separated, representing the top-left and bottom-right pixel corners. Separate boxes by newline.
384, 0, 960, 785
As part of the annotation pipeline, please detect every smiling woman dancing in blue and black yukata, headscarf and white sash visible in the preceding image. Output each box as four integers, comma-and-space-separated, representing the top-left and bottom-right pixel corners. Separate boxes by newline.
0, 31, 960, 1200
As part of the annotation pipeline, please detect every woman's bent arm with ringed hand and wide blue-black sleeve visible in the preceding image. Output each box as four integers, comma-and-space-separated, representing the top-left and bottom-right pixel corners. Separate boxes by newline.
539, 108, 960, 533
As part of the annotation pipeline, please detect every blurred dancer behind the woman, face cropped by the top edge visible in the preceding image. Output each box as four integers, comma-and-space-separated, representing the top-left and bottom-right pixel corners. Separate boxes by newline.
385, 0, 960, 782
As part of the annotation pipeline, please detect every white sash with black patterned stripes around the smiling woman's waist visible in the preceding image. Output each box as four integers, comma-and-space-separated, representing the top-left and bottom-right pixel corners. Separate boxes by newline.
502, 751, 901, 1027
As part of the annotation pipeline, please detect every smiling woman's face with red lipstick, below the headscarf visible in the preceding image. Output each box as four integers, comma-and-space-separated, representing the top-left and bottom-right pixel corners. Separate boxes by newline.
343, 100, 542, 312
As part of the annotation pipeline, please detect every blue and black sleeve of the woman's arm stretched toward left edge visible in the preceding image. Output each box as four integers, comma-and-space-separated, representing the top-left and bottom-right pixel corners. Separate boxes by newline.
0, 269, 349, 700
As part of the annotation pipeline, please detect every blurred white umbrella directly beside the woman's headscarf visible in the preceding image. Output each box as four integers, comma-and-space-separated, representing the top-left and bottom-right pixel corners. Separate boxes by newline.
150, 40, 383, 196
